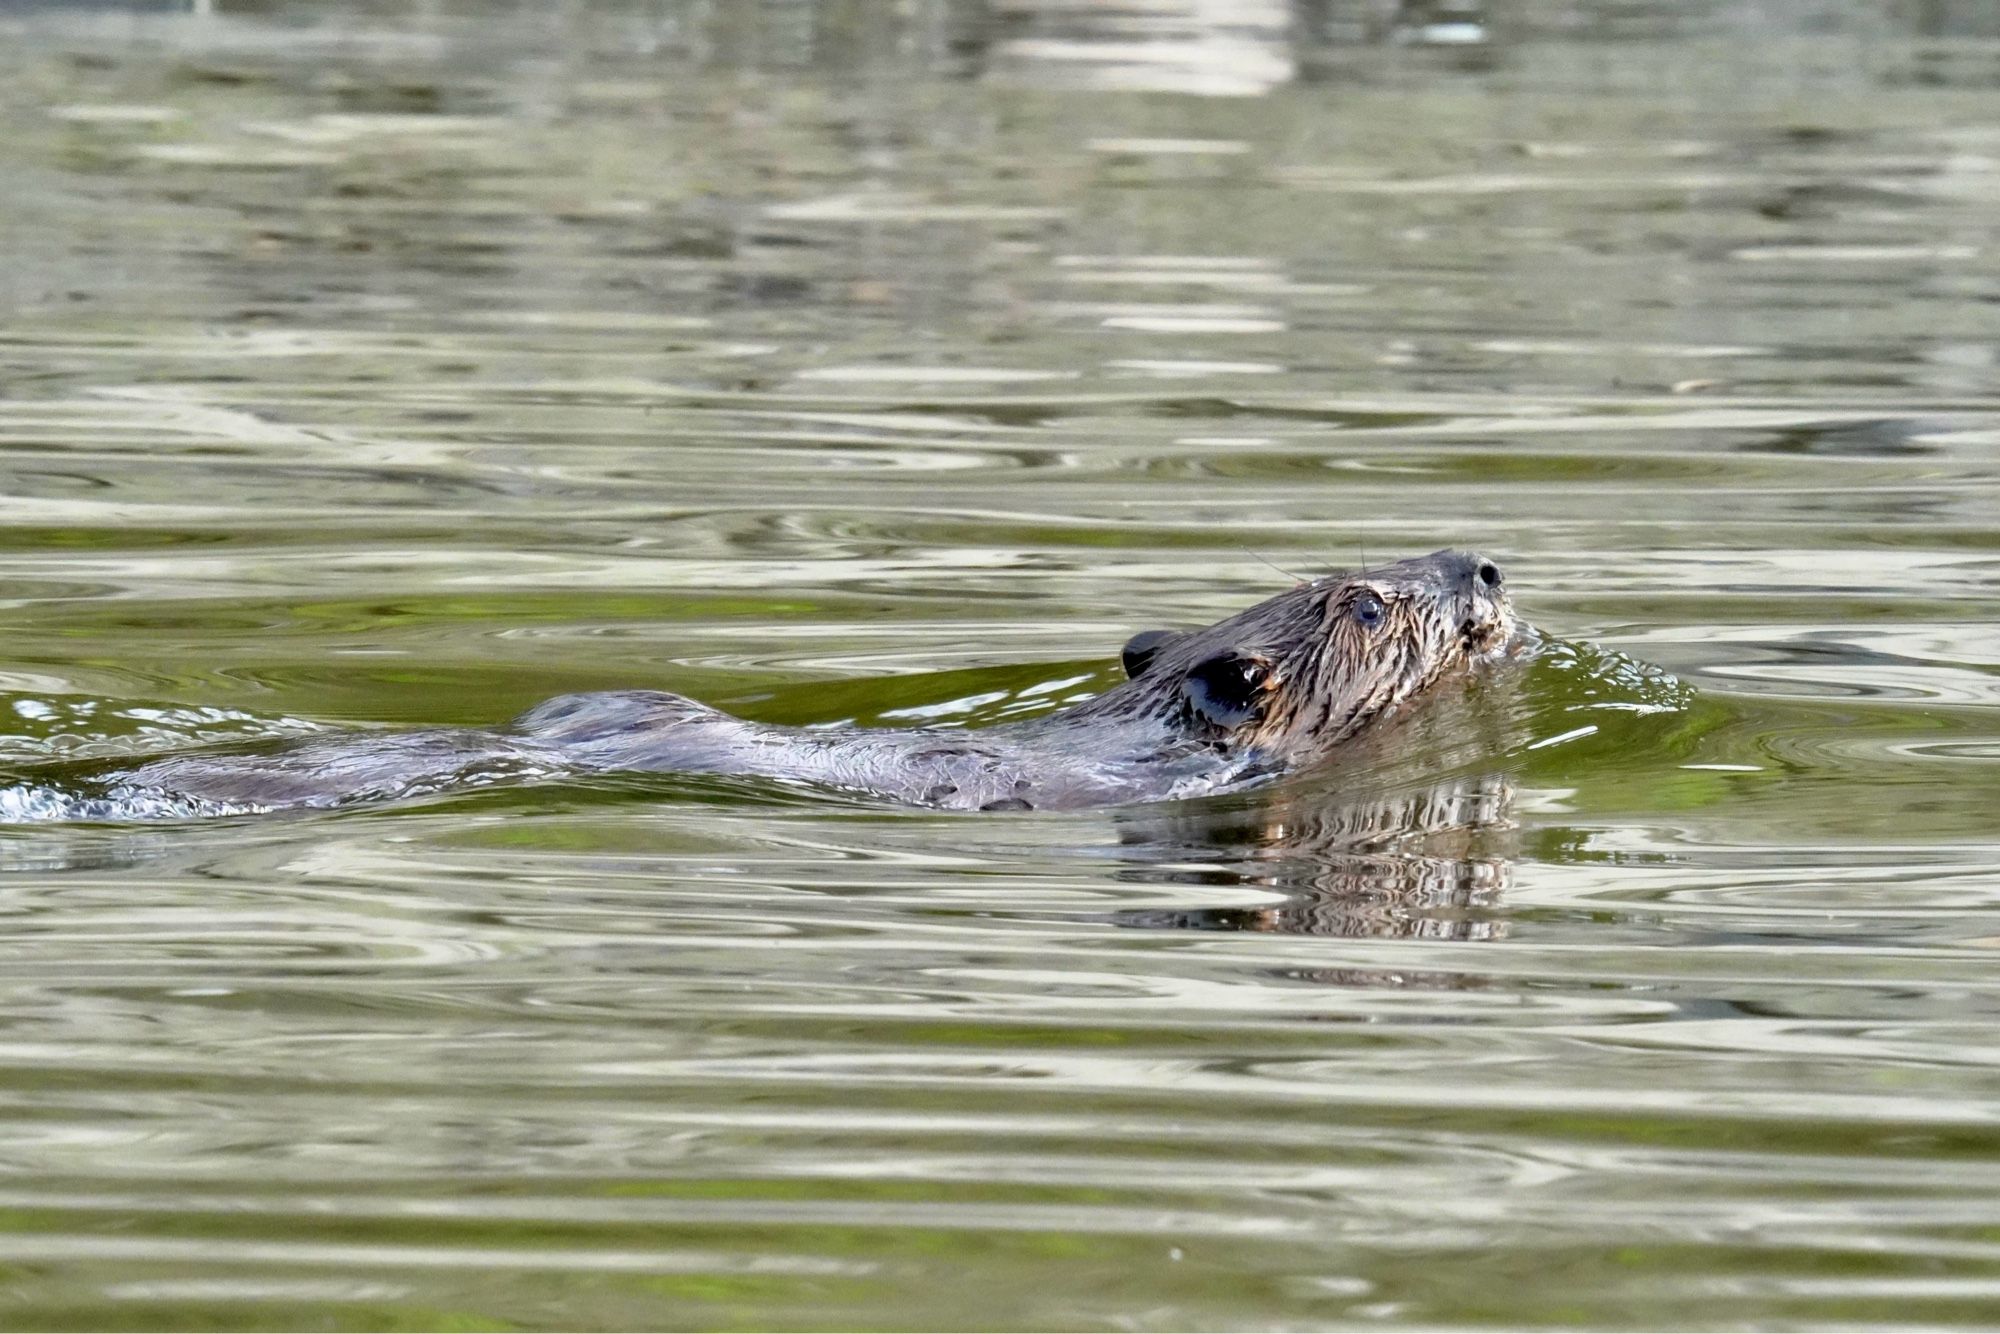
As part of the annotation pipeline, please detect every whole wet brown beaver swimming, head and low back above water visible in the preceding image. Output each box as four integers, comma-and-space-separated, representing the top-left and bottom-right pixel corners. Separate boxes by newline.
90, 552, 1514, 810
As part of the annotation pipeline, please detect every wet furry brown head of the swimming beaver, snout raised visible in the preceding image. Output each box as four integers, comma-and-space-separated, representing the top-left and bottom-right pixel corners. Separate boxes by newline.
1100, 550, 1514, 760
